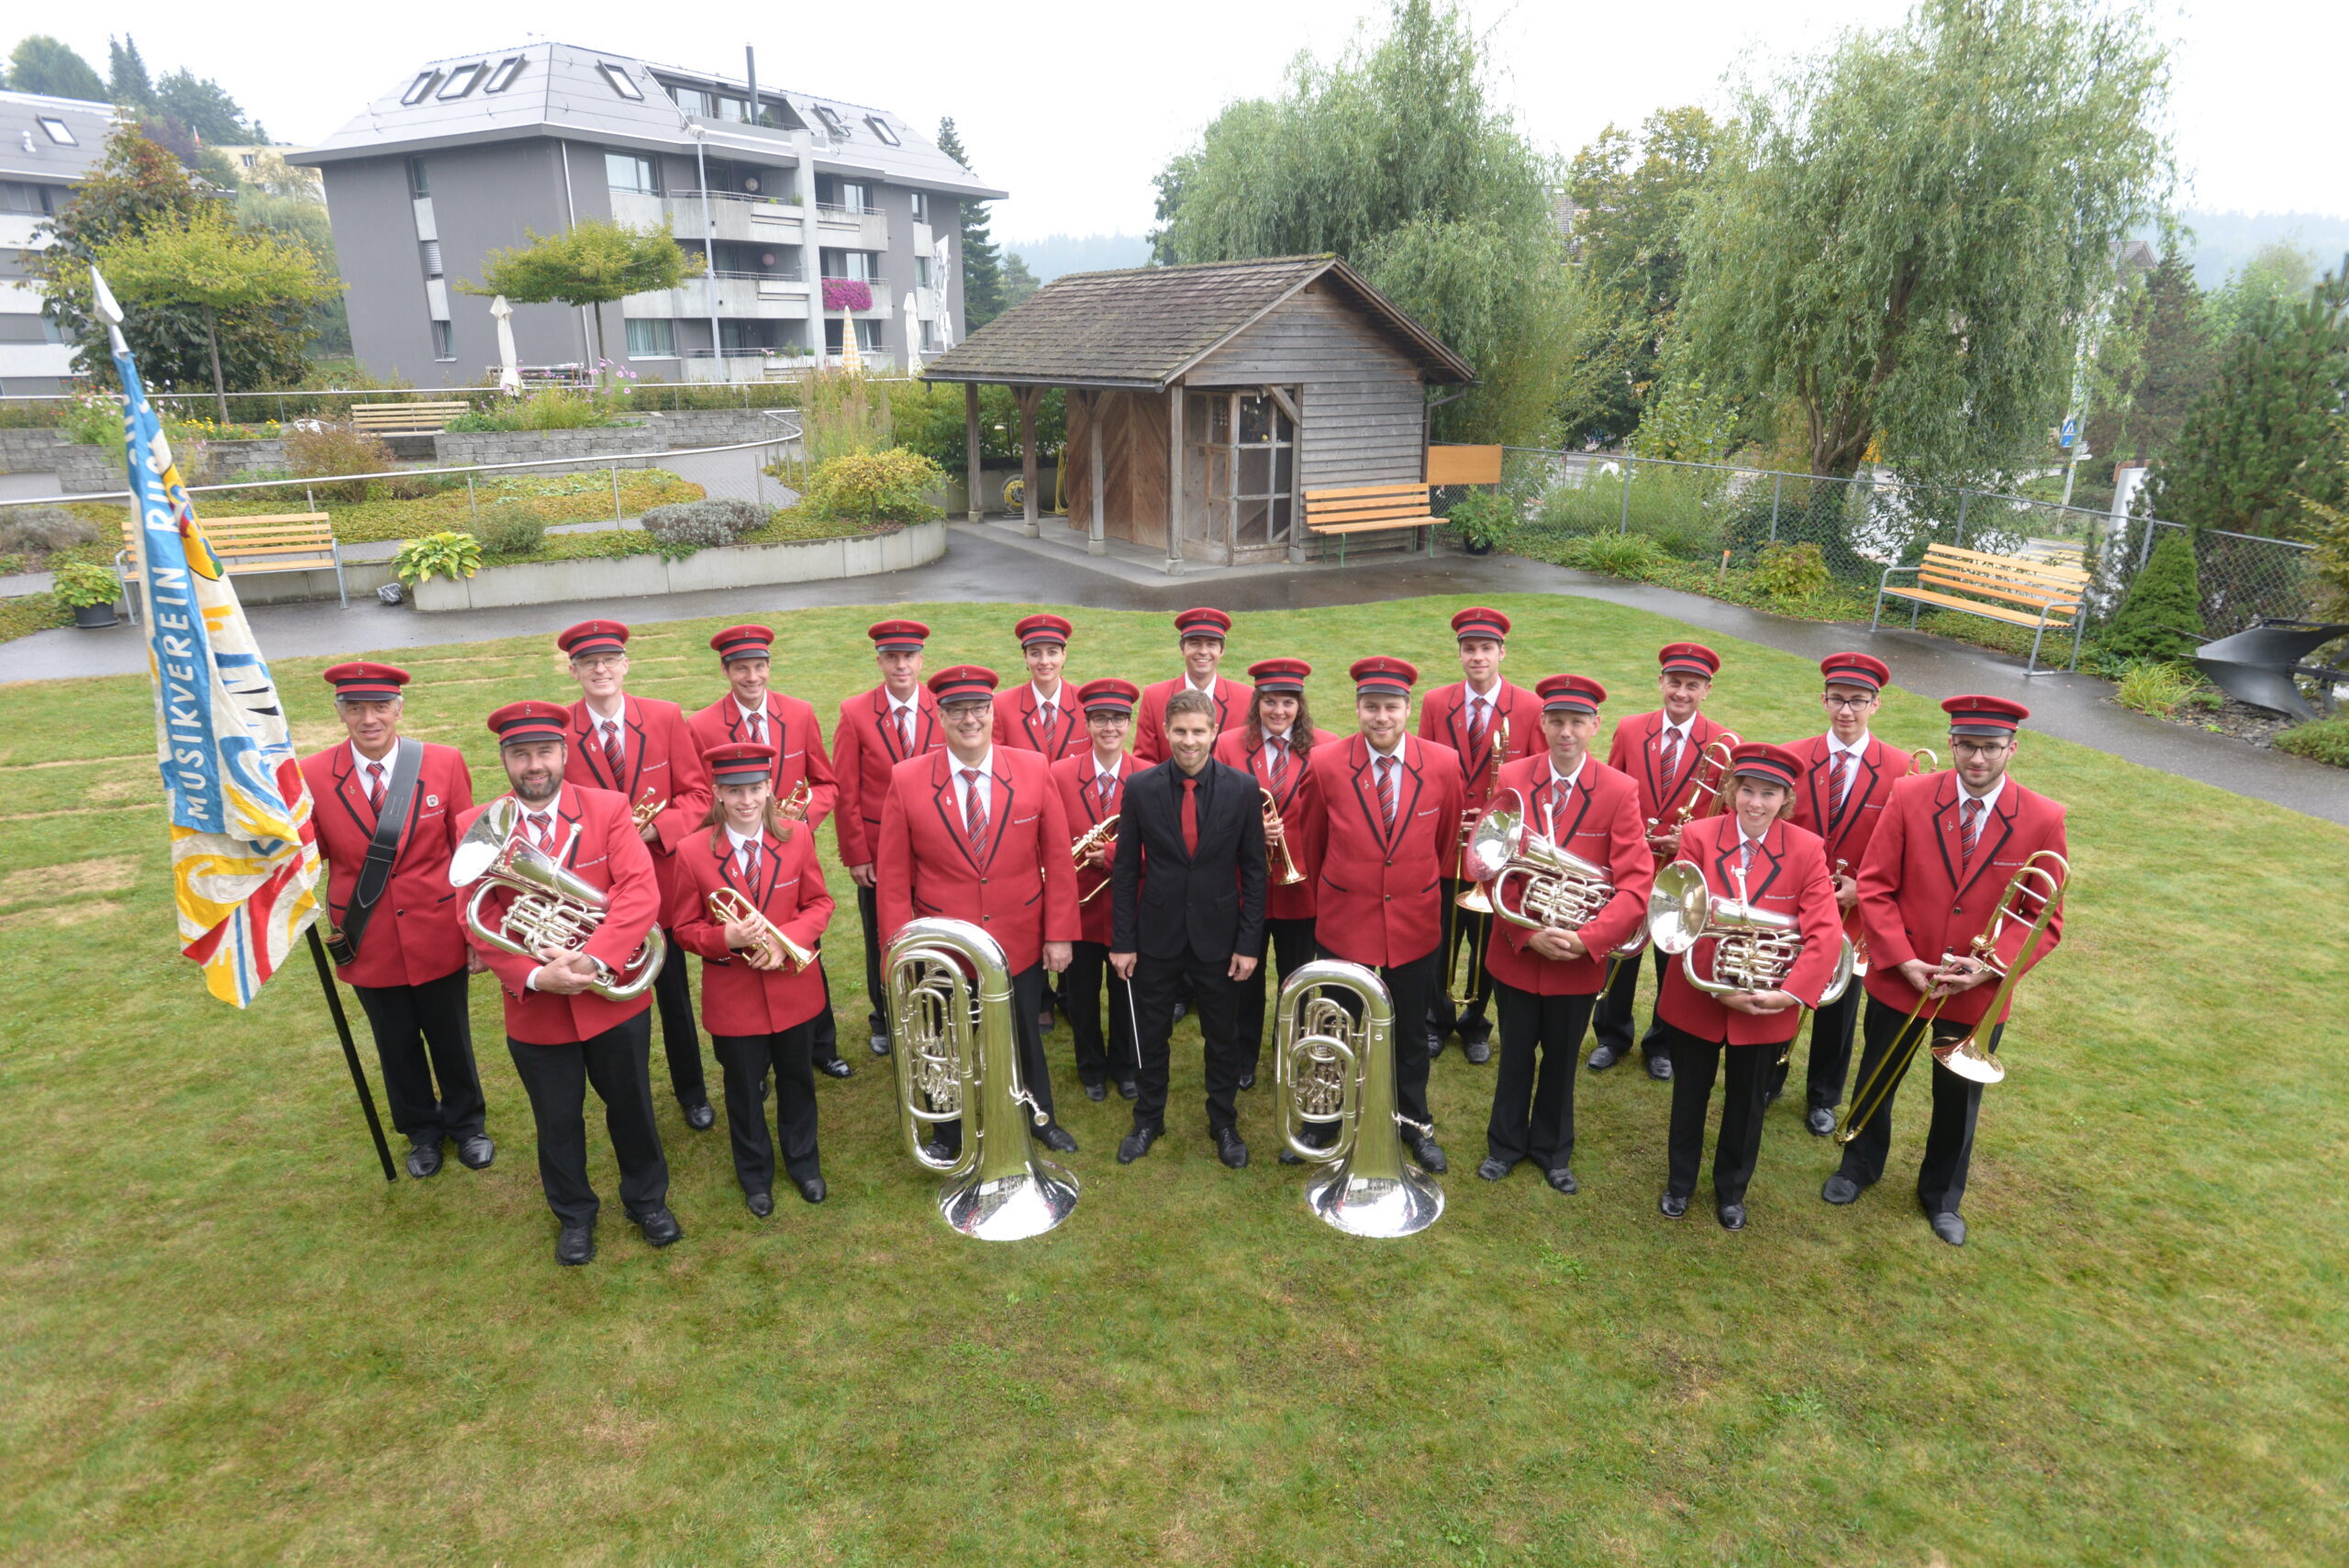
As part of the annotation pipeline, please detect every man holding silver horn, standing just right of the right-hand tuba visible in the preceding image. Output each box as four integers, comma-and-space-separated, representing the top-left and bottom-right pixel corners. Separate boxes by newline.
1475, 676, 1656, 1193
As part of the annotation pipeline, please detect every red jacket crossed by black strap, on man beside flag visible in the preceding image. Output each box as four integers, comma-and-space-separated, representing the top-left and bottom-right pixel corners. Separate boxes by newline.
301, 741, 473, 986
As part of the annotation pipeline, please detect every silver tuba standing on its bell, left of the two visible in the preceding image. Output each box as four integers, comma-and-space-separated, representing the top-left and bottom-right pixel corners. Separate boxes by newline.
881, 917, 1075, 1241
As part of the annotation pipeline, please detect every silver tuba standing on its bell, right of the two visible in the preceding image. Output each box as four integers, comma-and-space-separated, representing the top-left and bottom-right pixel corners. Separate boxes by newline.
1274, 958, 1444, 1237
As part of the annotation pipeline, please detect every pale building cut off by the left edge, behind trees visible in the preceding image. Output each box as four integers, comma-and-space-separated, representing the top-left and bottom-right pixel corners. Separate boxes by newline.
0, 92, 115, 396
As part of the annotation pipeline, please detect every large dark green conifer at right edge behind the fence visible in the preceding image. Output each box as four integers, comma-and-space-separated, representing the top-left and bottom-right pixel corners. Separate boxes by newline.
2144, 261, 2349, 538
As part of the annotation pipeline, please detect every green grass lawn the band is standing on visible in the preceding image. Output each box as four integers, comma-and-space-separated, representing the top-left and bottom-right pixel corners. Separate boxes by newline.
0, 596, 2349, 1568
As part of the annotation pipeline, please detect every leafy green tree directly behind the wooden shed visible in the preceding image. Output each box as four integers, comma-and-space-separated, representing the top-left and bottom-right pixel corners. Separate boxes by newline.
1151, 0, 1588, 446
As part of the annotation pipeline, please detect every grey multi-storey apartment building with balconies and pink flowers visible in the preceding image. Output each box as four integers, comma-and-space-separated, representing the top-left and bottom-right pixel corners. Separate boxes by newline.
289, 42, 1006, 385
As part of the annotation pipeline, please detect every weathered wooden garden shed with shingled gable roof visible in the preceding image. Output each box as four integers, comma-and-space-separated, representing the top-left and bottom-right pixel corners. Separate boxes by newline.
921, 256, 1475, 573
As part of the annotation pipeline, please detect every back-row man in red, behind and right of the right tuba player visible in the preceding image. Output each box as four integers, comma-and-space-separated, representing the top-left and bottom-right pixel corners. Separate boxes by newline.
1419, 608, 1541, 1066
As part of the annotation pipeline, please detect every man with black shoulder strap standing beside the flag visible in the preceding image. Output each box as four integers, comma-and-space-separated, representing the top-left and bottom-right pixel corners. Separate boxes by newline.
301, 662, 498, 1181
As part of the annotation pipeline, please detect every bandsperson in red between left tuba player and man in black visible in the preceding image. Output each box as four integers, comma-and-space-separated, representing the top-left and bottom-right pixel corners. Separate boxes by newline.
1052, 676, 1141, 1101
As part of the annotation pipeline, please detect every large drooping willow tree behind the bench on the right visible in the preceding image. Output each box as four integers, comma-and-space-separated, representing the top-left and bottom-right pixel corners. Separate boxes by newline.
1679, 0, 2170, 481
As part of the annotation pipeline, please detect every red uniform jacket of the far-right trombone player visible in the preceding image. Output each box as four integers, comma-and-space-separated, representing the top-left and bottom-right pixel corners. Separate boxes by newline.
1861, 773, 2069, 1023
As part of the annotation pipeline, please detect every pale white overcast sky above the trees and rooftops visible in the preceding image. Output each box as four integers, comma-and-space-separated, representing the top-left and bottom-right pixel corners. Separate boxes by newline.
41, 0, 2349, 239
